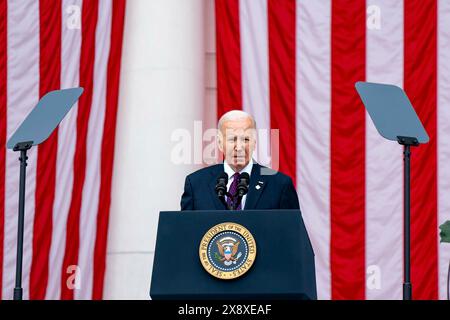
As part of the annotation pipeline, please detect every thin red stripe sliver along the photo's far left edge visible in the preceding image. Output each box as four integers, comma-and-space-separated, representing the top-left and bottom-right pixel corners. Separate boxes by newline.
0, 0, 8, 299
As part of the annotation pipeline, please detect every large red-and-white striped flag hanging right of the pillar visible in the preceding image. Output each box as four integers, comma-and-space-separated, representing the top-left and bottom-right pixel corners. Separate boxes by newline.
215, 0, 450, 299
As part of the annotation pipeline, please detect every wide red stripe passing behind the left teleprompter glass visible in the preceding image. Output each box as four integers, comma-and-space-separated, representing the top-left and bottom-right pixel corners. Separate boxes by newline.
30, 0, 61, 299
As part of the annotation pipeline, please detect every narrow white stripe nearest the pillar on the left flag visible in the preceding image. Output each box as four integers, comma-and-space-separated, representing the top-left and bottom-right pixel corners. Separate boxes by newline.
75, 0, 112, 299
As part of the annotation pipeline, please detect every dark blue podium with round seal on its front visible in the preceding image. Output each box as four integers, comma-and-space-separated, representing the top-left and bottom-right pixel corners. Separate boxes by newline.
150, 210, 317, 300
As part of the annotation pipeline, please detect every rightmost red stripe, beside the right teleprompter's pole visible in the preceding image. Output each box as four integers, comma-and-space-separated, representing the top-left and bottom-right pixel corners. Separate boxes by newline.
404, 0, 438, 299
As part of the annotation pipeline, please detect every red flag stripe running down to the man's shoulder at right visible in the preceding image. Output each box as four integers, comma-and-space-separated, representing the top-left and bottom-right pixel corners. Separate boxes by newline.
268, 0, 297, 181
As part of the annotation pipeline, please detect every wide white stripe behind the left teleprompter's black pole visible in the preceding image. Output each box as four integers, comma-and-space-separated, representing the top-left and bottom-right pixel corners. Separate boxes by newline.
2, 0, 39, 299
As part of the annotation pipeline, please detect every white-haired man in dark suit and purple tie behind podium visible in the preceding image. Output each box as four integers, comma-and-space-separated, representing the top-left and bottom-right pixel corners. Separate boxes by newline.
181, 110, 300, 210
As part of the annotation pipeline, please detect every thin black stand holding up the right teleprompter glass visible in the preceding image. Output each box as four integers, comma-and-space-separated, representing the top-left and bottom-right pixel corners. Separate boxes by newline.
397, 136, 419, 300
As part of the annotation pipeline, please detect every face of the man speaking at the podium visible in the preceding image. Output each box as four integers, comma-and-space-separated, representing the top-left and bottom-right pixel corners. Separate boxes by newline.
218, 118, 256, 171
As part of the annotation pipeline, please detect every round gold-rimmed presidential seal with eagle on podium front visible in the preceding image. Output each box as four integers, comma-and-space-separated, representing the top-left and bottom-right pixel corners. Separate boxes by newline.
199, 222, 256, 280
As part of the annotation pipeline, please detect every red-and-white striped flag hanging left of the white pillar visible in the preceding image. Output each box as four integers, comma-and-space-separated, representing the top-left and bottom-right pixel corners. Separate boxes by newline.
0, 0, 125, 299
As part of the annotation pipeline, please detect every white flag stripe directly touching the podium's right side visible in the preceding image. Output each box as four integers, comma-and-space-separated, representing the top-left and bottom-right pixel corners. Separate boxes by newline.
296, 0, 331, 299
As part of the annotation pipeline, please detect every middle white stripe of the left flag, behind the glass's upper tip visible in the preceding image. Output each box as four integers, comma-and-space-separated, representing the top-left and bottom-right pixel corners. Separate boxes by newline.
45, 0, 82, 299
